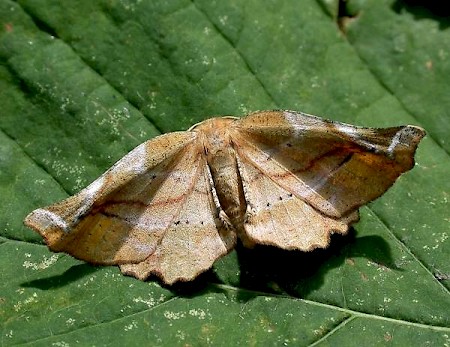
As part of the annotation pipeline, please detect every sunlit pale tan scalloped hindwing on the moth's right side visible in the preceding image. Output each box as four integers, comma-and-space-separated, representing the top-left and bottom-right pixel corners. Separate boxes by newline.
238, 151, 358, 251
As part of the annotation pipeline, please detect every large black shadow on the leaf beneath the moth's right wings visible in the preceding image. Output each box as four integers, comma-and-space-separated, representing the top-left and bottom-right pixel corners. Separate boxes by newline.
232, 228, 398, 301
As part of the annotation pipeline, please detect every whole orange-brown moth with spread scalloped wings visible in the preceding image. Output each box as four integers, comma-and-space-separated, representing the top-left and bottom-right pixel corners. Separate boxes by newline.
25, 111, 425, 284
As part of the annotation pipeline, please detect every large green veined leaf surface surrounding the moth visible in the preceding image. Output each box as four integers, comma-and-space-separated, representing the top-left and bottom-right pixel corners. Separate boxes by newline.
0, 0, 450, 346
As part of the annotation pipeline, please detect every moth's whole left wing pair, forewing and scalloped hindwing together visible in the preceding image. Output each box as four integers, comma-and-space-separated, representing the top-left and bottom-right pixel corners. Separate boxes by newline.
25, 132, 235, 283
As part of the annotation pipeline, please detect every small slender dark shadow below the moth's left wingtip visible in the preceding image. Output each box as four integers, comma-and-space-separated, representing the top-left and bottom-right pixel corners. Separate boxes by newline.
20, 263, 98, 290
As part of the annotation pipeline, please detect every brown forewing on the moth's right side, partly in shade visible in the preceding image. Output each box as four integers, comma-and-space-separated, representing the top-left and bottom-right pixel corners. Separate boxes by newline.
233, 111, 425, 218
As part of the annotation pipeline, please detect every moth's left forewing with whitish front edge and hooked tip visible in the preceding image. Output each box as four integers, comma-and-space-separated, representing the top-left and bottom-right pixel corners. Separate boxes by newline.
25, 133, 194, 264
